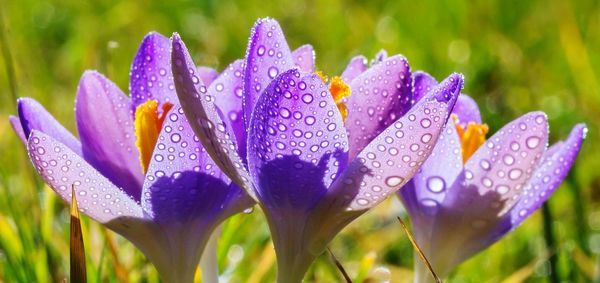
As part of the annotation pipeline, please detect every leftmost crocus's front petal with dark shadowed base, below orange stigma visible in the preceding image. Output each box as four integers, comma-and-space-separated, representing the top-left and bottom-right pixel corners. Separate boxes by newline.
142, 106, 251, 224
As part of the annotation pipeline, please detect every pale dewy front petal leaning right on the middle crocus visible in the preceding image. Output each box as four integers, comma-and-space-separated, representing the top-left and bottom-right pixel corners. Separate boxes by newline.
331, 74, 463, 210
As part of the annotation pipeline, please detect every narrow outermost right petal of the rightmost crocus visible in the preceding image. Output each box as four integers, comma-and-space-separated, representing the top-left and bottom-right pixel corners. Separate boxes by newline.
510, 124, 587, 229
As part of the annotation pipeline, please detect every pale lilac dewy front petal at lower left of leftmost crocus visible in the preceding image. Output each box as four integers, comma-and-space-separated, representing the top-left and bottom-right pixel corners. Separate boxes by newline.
28, 130, 143, 223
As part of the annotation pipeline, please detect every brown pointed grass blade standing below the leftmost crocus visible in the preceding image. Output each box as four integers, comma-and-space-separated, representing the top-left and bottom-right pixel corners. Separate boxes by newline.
70, 186, 87, 283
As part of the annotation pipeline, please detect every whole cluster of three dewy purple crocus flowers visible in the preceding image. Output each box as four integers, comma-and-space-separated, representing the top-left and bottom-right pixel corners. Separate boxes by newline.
10, 18, 586, 282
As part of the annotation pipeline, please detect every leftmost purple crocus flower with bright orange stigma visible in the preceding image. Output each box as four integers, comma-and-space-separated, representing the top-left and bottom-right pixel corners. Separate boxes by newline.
10, 33, 252, 282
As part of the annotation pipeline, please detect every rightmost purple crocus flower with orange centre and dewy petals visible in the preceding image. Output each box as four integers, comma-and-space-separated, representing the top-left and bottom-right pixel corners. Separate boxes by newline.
399, 87, 587, 282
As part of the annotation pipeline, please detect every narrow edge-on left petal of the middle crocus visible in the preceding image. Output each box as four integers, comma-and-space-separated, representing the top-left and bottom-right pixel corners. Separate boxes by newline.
171, 33, 254, 201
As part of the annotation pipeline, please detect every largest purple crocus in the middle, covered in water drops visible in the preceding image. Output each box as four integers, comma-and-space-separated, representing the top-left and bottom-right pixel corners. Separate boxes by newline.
172, 19, 463, 282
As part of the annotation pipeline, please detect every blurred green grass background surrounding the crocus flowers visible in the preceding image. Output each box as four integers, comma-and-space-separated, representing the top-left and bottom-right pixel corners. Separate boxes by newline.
0, 0, 600, 282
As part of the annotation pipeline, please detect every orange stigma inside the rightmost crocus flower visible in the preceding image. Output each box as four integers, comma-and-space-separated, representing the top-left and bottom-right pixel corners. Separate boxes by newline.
451, 114, 489, 164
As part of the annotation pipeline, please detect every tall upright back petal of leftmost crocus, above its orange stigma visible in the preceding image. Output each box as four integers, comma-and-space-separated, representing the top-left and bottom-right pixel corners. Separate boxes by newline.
129, 32, 177, 111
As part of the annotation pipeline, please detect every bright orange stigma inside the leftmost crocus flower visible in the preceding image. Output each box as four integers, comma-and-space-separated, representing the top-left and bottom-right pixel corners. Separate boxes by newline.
134, 100, 173, 174
